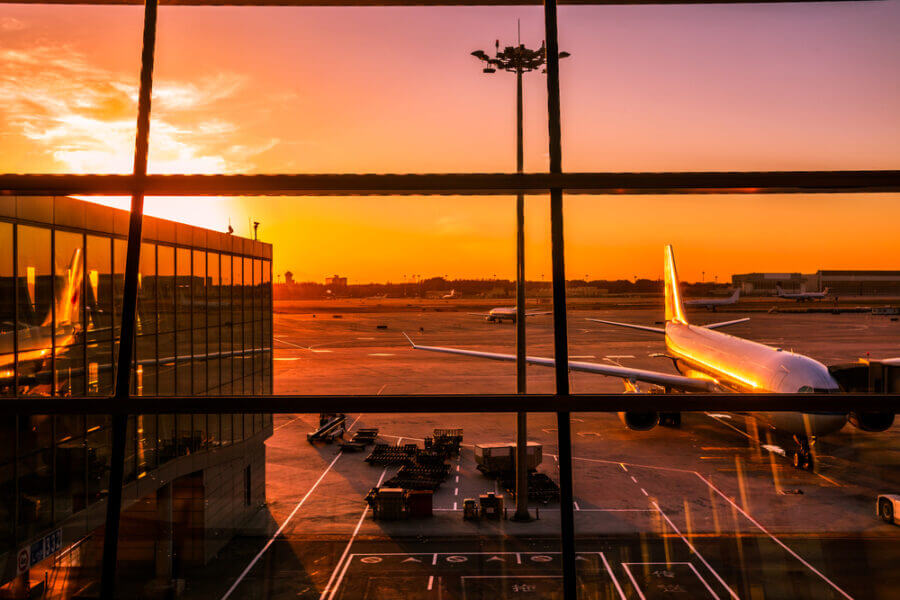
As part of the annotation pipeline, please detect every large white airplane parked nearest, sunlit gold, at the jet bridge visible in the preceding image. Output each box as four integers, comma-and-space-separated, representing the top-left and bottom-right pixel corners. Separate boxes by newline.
404, 246, 894, 470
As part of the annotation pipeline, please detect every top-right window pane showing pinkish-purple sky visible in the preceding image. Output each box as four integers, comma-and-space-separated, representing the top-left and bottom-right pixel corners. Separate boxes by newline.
560, 2, 900, 172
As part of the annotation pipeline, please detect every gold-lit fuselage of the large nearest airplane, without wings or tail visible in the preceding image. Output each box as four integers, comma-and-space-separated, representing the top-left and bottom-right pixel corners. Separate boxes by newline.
666, 322, 847, 436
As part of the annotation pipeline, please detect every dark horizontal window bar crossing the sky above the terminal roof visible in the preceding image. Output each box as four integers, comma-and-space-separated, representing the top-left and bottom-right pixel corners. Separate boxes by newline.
0, 170, 900, 196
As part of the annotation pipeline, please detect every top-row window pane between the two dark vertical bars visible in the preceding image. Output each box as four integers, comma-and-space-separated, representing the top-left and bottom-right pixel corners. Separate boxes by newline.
149, 6, 528, 175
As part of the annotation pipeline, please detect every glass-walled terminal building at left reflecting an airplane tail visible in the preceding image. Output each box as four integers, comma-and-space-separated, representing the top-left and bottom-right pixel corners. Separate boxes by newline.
0, 196, 272, 593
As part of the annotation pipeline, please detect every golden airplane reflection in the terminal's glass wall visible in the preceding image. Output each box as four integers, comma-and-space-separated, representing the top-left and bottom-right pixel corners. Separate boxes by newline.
0, 248, 84, 386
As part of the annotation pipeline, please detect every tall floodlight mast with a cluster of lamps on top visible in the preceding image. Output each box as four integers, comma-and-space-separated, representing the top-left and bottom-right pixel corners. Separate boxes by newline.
472, 22, 569, 521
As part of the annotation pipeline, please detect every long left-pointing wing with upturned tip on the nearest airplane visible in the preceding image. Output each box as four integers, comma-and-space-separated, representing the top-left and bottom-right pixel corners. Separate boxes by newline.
403, 333, 716, 392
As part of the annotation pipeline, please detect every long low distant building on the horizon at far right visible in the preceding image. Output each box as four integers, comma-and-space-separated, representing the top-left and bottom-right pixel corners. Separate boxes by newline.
731, 270, 900, 297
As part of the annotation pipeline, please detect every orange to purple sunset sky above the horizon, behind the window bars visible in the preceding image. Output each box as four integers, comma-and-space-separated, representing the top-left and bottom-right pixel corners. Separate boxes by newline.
0, 0, 900, 282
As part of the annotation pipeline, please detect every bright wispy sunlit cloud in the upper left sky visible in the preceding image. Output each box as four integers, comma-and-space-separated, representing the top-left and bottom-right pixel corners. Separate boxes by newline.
0, 41, 277, 173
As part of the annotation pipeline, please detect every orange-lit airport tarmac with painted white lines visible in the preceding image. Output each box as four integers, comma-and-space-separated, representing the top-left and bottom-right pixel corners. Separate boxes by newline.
186, 301, 900, 600
